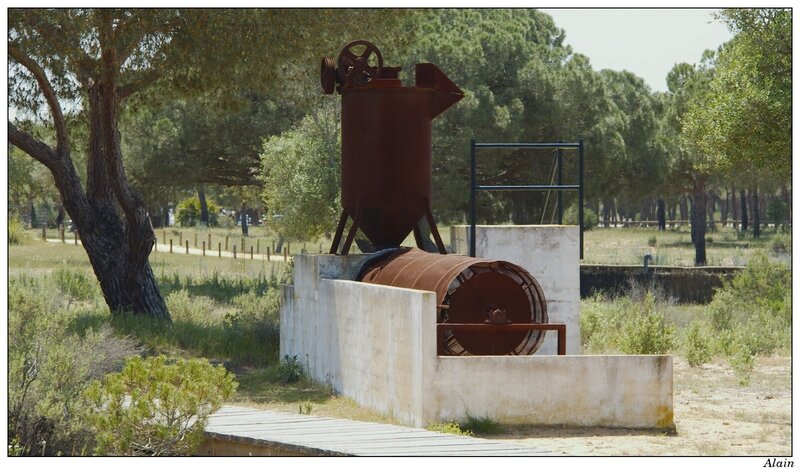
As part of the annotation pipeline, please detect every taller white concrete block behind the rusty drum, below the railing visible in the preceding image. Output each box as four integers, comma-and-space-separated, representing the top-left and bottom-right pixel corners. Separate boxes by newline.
450, 225, 581, 354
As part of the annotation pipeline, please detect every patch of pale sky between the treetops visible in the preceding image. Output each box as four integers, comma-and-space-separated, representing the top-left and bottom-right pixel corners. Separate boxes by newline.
541, 8, 733, 92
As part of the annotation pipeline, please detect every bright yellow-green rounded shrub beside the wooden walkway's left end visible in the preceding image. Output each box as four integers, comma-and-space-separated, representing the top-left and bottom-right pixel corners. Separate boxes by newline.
86, 356, 237, 456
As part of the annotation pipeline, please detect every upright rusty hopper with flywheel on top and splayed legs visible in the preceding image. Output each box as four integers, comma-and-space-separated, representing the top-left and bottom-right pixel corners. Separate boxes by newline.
321, 41, 463, 254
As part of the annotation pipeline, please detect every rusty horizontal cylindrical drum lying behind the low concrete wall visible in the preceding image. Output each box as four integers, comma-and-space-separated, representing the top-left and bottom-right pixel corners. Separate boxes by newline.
360, 248, 547, 355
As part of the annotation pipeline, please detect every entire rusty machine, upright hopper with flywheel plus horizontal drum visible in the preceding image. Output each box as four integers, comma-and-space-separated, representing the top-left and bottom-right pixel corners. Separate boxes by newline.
320, 41, 566, 355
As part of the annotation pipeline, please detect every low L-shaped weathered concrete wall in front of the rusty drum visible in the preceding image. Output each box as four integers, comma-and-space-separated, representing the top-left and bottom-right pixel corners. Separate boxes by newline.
281, 255, 674, 428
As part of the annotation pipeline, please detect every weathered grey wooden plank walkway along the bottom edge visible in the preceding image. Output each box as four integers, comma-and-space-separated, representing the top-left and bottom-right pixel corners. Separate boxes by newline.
203, 406, 552, 456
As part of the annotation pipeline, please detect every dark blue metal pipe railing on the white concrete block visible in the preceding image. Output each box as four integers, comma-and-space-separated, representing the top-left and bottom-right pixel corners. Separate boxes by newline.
469, 138, 583, 259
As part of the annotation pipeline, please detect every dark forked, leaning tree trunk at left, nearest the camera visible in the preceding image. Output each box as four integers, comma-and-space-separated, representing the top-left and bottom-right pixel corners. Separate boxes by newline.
8, 37, 170, 320
